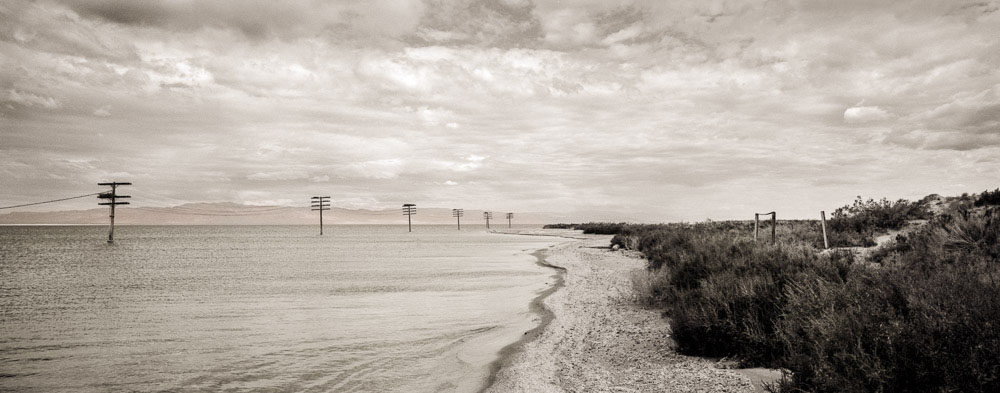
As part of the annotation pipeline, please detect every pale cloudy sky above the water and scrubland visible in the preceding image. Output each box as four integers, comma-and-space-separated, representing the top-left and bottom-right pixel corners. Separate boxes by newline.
0, 0, 1000, 221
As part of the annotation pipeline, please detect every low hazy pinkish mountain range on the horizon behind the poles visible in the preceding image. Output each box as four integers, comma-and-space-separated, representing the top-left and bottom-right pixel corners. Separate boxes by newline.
0, 202, 616, 226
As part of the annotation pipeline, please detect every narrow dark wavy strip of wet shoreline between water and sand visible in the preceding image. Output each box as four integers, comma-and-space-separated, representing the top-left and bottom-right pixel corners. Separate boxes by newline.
477, 247, 566, 393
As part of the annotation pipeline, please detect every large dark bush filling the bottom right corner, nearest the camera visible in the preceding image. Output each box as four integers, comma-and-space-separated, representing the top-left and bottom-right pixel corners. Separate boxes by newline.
777, 209, 1000, 392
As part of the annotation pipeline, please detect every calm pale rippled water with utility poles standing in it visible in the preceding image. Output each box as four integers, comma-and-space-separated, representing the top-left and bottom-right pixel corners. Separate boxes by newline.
0, 226, 557, 392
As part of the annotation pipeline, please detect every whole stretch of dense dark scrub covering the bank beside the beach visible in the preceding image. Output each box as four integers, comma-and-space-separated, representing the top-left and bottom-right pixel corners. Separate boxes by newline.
589, 193, 1000, 392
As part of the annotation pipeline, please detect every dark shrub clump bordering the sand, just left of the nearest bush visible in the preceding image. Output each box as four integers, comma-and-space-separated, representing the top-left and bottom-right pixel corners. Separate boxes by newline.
620, 222, 842, 365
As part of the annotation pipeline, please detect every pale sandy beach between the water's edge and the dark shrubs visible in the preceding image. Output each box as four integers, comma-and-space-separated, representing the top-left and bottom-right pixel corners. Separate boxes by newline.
484, 231, 774, 392
